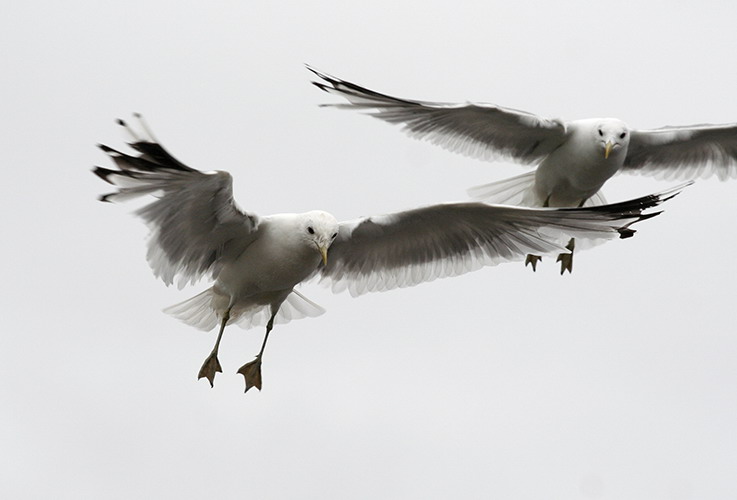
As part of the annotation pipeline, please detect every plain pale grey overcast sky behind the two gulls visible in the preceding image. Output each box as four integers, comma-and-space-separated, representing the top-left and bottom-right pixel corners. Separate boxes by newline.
0, 0, 737, 500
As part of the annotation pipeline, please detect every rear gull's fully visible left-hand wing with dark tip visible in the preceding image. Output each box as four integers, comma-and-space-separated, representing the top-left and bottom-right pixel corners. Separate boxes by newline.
307, 66, 566, 164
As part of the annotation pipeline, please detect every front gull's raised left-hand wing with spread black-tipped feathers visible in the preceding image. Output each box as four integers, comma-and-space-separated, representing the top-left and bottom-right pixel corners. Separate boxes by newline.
93, 117, 259, 288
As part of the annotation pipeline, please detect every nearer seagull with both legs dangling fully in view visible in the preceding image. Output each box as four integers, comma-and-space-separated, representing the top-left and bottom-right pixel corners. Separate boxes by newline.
93, 114, 684, 392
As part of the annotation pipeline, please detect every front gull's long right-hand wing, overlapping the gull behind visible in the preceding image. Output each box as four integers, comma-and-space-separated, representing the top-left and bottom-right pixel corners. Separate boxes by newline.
320, 186, 683, 295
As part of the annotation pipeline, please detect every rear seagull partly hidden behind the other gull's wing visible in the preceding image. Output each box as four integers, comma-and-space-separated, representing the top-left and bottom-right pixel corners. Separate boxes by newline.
307, 65, 737, 274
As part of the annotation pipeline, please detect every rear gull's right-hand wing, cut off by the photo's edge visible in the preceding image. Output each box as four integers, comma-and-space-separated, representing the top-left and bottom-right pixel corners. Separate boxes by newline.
622, 124, 737, 180
